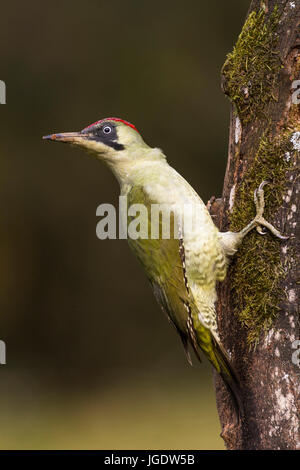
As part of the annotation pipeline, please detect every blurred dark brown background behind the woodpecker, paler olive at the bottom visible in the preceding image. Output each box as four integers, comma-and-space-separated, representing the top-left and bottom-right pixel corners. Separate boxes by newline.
0, 0, 249, 449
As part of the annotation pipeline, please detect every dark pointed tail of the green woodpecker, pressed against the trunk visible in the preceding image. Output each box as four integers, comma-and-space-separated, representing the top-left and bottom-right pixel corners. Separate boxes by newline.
212, 335, 244, 422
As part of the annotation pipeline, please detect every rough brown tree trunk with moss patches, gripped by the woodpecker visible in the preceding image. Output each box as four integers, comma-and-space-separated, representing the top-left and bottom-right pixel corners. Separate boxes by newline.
213, 0, 300, 449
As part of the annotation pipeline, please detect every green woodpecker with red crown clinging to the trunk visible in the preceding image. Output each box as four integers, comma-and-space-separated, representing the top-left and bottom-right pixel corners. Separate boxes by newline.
44, 118, 284, 413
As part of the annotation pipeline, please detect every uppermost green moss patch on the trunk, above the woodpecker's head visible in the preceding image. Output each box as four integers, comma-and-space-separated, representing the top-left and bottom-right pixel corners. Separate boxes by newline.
222, 7, 281, 124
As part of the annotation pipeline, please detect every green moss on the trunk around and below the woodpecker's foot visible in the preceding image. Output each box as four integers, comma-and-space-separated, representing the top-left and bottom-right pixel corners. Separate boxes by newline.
230, 129, 295, 345
